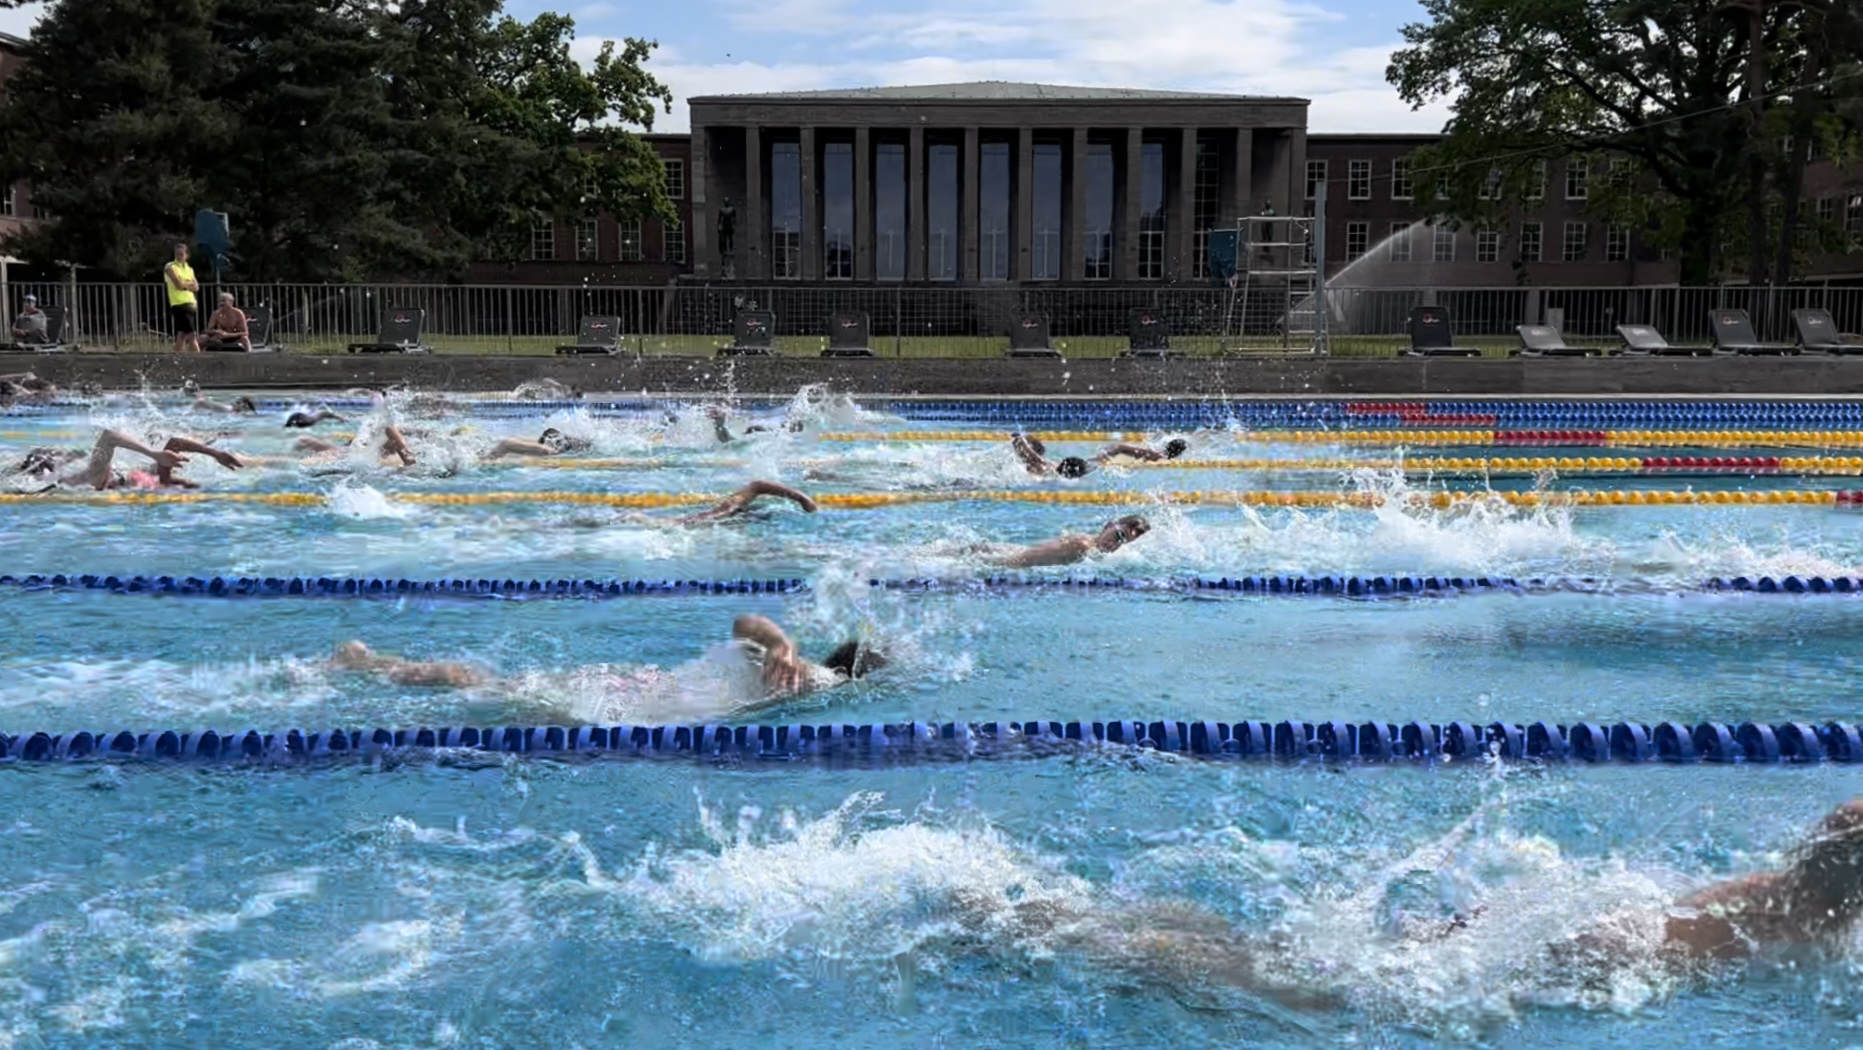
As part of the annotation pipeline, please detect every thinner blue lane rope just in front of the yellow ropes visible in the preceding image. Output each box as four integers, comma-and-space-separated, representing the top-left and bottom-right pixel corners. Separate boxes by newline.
0, 573, 1863, 599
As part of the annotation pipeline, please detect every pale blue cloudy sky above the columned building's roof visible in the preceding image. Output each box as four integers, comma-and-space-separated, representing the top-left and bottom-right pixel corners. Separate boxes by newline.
0, 0, 1448, 132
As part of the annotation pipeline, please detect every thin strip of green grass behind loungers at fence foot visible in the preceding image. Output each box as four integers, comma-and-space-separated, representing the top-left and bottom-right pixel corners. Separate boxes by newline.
86, 335, 1606, 359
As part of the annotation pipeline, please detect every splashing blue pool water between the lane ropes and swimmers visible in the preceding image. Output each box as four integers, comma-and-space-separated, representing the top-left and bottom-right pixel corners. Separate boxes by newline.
0, 389, 1863, 1050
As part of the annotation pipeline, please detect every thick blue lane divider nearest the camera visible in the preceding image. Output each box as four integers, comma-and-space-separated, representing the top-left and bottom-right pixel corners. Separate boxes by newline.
0, 720, 1863, 765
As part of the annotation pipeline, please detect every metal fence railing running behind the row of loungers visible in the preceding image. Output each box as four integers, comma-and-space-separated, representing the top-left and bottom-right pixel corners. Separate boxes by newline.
4, 281, 1863, 356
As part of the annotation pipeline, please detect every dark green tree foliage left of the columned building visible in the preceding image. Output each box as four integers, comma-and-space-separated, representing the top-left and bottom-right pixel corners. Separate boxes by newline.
0, 0, 673, 281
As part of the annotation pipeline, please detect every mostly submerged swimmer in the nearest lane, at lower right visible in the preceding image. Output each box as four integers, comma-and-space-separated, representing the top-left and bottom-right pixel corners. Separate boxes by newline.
952, 801, 1863, 1009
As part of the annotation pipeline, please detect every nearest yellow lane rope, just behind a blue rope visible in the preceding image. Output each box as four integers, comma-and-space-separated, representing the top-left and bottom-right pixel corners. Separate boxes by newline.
0, 490, 1850, 510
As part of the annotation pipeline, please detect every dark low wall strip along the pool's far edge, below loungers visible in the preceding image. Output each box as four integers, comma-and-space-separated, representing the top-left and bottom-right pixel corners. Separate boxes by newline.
25, 354, 1863, 397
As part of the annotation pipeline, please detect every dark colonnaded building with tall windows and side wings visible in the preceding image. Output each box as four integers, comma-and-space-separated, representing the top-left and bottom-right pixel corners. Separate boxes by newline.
481, 82, 1863, 287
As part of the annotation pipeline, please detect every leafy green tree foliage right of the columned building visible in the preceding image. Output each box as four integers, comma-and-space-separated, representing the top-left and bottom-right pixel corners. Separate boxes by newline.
1388, 0, 1863, 283
